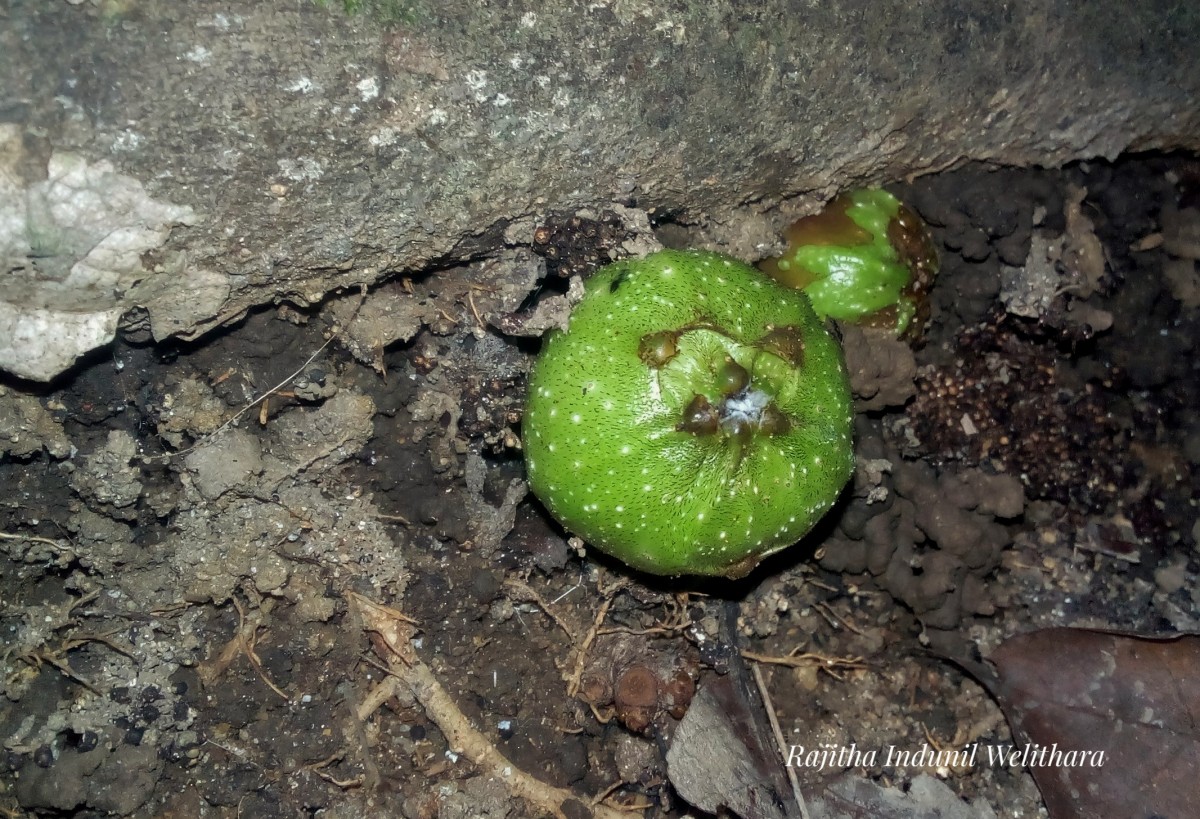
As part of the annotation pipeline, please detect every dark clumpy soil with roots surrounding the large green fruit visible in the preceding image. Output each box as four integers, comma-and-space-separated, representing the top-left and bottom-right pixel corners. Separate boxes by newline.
0, 156, 1200, 819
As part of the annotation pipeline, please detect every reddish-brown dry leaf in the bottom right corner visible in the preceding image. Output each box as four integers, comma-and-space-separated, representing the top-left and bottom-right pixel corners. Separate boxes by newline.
990, 628, 1200, 819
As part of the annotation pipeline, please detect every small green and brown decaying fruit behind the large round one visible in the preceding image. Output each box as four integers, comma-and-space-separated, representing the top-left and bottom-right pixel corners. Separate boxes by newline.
758, 189, 937, 337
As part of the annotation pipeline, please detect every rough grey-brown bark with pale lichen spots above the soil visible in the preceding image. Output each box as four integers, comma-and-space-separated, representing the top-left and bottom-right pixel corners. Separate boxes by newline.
0, 0, 1200, 362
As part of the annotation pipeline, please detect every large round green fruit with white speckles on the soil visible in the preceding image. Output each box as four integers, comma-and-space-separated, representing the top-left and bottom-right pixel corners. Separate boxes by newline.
523, 250, 853, 576
